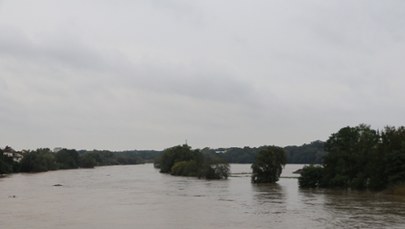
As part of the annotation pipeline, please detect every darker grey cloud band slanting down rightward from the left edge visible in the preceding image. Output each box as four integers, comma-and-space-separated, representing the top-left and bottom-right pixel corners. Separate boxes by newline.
0, 25, 262, 108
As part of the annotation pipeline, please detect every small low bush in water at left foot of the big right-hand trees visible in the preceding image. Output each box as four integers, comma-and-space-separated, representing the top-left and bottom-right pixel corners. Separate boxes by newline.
298, 165, 323, 188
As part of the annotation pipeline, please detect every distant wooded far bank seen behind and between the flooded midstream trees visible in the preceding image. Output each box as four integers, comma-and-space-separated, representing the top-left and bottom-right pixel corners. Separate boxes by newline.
0, 141, 326, 174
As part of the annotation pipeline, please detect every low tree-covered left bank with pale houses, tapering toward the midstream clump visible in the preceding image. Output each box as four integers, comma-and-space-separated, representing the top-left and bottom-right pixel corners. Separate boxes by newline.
0, 146, 160, 174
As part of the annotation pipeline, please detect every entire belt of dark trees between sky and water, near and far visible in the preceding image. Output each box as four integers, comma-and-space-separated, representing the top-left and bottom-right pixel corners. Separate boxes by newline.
6, 124, 405, 190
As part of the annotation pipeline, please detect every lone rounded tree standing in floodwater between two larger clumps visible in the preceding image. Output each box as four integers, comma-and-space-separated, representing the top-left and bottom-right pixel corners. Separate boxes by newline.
252, 146, 287, 183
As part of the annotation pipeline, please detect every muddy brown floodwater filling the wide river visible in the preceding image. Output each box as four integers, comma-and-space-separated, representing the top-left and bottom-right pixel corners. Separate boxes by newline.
0, 164, 405, 229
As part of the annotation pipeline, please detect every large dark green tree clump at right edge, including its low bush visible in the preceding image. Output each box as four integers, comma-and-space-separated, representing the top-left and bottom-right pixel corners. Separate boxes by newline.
299, 124, 405, 190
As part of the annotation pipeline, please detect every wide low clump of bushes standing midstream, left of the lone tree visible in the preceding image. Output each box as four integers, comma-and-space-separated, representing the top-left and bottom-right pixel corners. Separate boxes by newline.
155, 145, 229, 179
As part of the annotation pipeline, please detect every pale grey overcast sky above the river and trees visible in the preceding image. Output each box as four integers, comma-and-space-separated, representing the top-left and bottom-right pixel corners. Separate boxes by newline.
0, 0, 405, 150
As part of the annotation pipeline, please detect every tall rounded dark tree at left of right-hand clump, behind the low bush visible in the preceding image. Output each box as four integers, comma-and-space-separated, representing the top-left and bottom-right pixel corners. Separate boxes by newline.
324, 124, 382, 189
